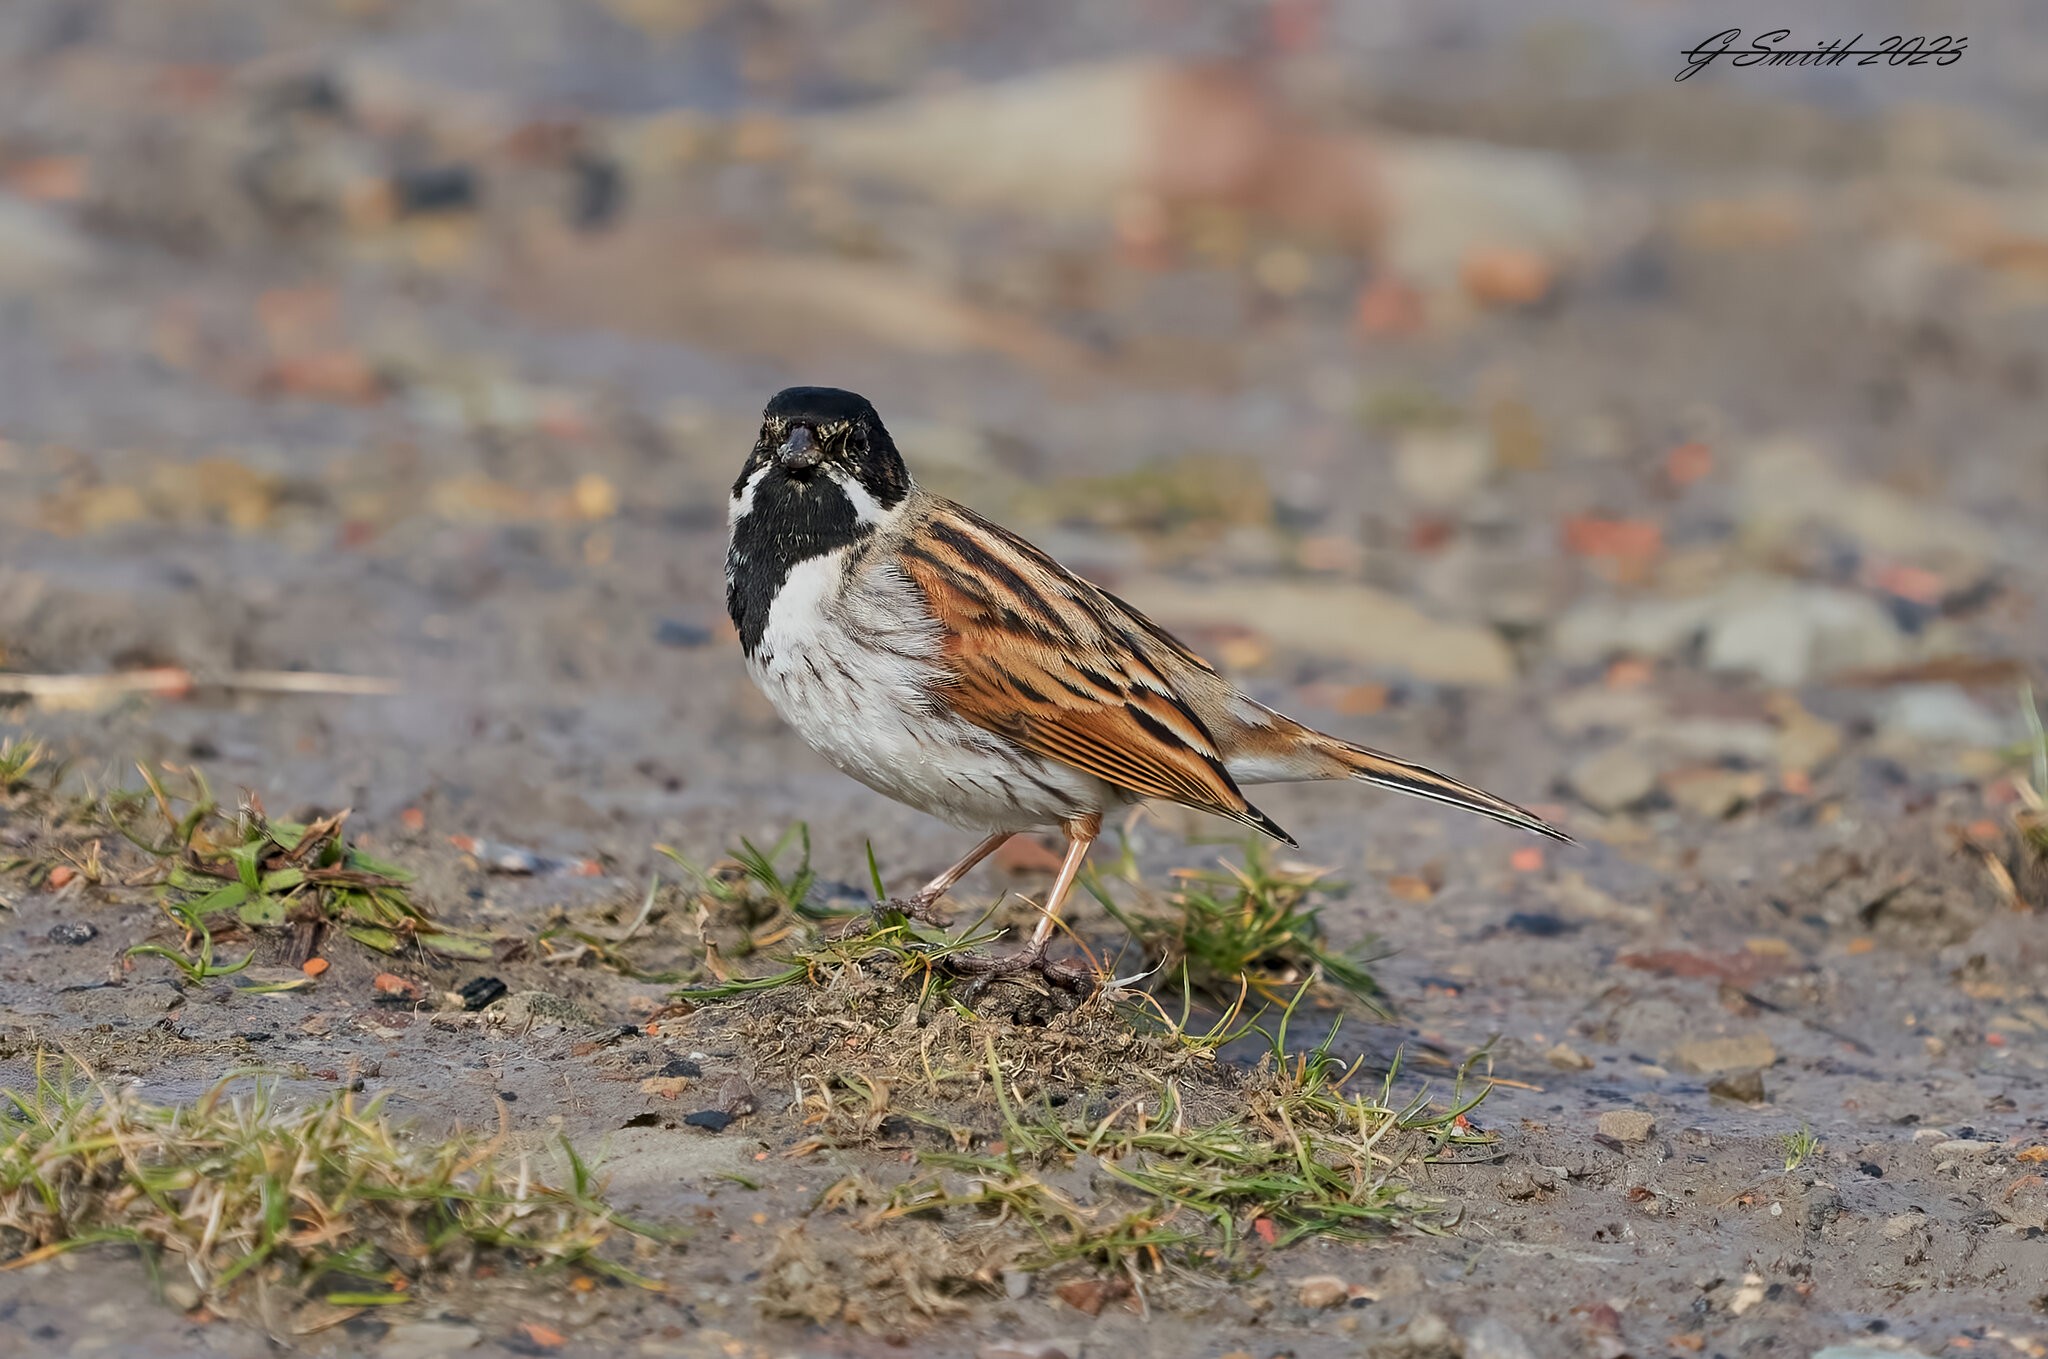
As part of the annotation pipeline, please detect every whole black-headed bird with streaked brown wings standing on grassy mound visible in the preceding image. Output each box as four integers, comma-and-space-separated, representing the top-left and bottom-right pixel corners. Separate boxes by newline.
725, 387, 1571, 991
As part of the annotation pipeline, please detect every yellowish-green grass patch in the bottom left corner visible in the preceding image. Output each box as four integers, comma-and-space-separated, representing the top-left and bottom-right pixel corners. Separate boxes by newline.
0, 1062, 666, 1324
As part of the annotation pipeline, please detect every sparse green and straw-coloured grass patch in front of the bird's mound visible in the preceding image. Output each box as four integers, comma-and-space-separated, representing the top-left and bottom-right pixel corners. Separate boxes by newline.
780, 987, 1487, 1312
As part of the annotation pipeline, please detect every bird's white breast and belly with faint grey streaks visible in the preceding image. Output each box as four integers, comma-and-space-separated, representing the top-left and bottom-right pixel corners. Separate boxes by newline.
748, 557, 1118, 831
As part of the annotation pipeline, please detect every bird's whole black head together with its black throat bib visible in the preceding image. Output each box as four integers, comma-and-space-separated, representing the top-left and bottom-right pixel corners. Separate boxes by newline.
725, 387, 911, 655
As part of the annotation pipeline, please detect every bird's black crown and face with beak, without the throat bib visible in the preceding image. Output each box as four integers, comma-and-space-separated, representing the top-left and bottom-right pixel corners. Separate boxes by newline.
733, 387, 909, 512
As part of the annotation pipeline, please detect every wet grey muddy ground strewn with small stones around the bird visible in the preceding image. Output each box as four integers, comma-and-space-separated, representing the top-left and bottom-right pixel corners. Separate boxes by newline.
0, 0, 2048, 1359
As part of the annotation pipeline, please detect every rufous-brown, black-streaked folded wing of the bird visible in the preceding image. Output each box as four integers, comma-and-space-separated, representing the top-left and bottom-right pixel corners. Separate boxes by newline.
901, 501, 1294, 843
